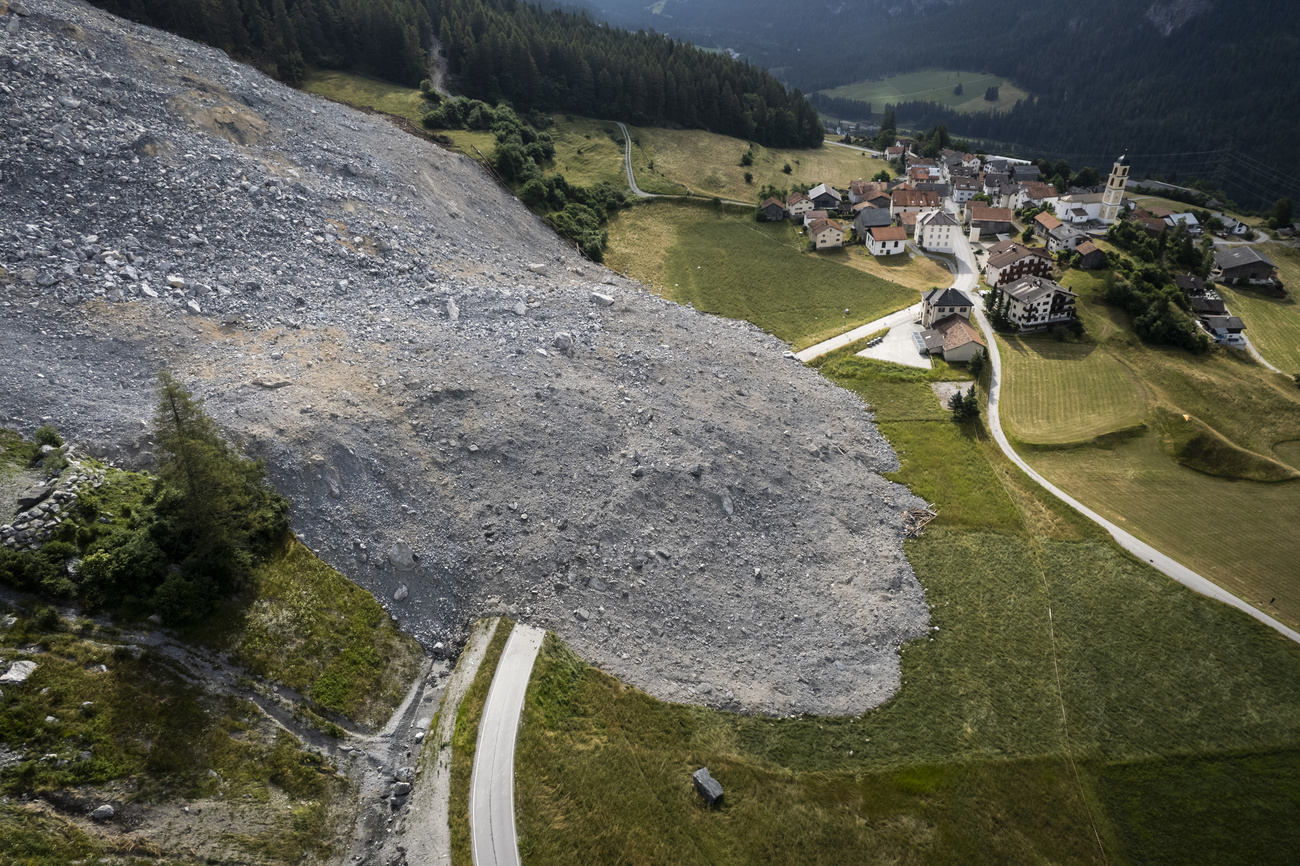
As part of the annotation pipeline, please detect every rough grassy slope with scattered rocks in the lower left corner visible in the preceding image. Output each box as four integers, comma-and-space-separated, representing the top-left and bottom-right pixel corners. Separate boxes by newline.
0, 430, 423, 865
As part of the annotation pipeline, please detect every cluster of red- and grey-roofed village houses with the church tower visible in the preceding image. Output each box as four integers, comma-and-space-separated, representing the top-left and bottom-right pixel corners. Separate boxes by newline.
759, 140, 1282, 351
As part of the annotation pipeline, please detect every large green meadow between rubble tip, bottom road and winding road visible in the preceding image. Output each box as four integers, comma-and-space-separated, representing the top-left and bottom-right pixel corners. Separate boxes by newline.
516, 348, 1300, 863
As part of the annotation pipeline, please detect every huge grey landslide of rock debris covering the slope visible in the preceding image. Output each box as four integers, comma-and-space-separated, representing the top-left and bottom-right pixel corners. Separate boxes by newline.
0, 0, 928, 714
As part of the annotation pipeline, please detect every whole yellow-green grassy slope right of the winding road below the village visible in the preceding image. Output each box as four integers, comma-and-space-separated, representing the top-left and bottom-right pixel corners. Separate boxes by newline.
987, 262, 1300, 627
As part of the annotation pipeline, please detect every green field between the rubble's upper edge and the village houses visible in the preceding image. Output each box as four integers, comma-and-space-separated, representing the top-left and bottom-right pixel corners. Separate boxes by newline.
606, 202, 917, 348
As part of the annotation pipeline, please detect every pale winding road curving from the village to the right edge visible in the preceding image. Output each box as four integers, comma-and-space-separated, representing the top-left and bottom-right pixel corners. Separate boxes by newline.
956, 222, 1300, 644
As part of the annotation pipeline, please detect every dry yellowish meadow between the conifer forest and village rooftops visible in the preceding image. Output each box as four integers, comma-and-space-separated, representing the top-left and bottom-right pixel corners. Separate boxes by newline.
629, 127, 889, 204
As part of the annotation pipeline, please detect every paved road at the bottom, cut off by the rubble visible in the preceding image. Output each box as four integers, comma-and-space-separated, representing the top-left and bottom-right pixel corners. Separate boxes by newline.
469, 625, 546, 866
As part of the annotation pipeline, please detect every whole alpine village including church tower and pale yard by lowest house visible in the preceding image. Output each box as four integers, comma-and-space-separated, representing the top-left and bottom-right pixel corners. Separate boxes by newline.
758, 139, 1286, 367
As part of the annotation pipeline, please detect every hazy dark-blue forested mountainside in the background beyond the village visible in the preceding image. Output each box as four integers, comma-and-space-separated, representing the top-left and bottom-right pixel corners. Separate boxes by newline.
595, 0, 1300, 204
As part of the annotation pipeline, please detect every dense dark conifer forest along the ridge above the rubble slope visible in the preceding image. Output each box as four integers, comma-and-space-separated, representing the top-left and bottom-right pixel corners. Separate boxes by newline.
86, 0, 822, 147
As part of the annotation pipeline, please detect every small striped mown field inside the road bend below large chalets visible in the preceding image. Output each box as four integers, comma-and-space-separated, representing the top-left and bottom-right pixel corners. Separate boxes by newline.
998, 337, 1147, 445
